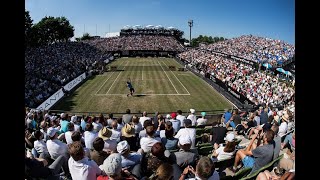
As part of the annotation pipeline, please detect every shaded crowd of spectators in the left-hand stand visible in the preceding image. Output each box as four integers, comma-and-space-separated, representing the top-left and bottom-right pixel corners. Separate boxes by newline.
25, 42, 110, 107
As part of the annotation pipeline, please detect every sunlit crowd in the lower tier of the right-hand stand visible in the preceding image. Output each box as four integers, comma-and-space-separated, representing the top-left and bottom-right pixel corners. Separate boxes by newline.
178, 49, 295, 106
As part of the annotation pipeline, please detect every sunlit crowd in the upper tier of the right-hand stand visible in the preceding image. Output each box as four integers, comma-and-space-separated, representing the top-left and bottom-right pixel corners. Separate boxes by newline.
207, 35, 295, 67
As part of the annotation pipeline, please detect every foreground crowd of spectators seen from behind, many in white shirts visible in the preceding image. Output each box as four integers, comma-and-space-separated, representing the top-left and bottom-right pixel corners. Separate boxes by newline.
25, 102, 295, 180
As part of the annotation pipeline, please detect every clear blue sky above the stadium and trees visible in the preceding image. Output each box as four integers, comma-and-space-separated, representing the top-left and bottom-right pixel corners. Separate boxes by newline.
25, 0, 295, 44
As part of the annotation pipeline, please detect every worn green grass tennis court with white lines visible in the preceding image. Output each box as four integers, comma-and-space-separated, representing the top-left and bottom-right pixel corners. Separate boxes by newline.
52, 58, 233, 113
